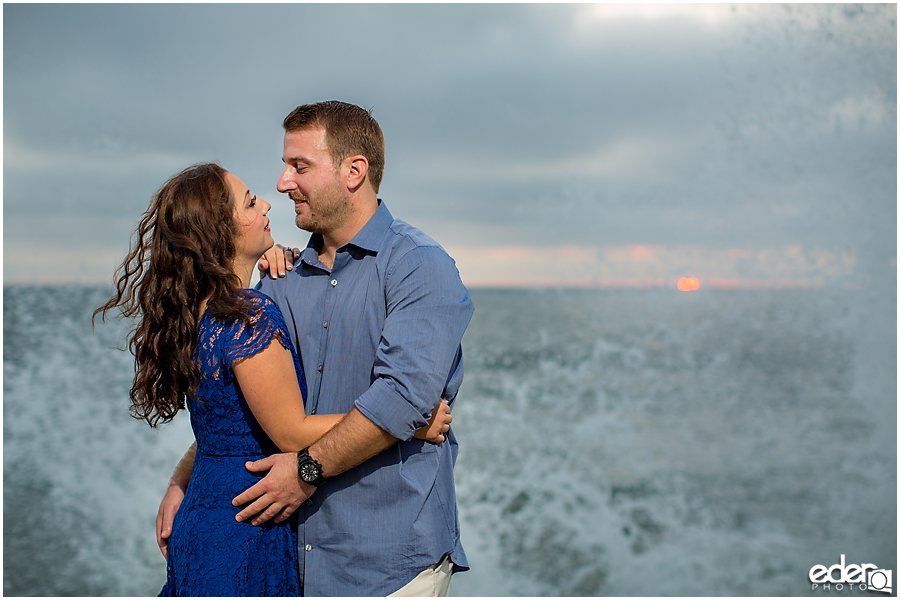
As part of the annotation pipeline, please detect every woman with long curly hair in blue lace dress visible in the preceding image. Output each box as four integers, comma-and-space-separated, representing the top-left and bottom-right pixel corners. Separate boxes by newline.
94, 164, 450, 596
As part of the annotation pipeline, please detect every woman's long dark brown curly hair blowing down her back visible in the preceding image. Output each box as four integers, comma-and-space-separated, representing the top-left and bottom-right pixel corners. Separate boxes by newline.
94, 163, 250, 427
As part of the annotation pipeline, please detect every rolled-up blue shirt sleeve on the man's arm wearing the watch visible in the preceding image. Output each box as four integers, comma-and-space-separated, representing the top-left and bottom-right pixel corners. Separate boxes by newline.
355, 246, 474, 440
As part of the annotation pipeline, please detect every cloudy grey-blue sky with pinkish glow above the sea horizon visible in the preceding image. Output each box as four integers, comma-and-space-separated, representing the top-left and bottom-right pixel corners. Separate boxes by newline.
3, 4, 897, 289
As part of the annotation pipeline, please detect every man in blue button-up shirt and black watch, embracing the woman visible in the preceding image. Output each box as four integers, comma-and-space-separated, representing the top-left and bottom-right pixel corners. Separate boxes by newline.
157, 102, 473, 596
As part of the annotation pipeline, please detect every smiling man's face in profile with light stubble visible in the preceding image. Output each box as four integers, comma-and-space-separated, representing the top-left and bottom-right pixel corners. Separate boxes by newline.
277, 129, 351, 235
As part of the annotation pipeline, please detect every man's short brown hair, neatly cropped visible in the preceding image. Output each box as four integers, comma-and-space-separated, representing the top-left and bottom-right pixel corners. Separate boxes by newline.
283, 100, 384, 193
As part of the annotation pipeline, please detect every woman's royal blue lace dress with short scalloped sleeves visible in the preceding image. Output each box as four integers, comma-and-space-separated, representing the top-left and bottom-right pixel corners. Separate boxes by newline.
160, 290, 306, 596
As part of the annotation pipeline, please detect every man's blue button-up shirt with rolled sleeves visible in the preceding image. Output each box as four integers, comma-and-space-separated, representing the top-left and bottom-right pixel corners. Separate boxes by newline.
259, 203, 473, 596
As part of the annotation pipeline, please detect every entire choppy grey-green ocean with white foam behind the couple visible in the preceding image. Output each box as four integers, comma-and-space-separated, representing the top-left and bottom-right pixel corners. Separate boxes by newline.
3, 286, 897, 596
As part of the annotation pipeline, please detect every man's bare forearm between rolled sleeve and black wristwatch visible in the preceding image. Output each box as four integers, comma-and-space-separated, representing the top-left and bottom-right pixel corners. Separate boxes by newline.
309, 407, 397, 477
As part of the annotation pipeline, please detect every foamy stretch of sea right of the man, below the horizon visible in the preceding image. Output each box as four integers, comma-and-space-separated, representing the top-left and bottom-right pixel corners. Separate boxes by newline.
454, 292, 896, 596
